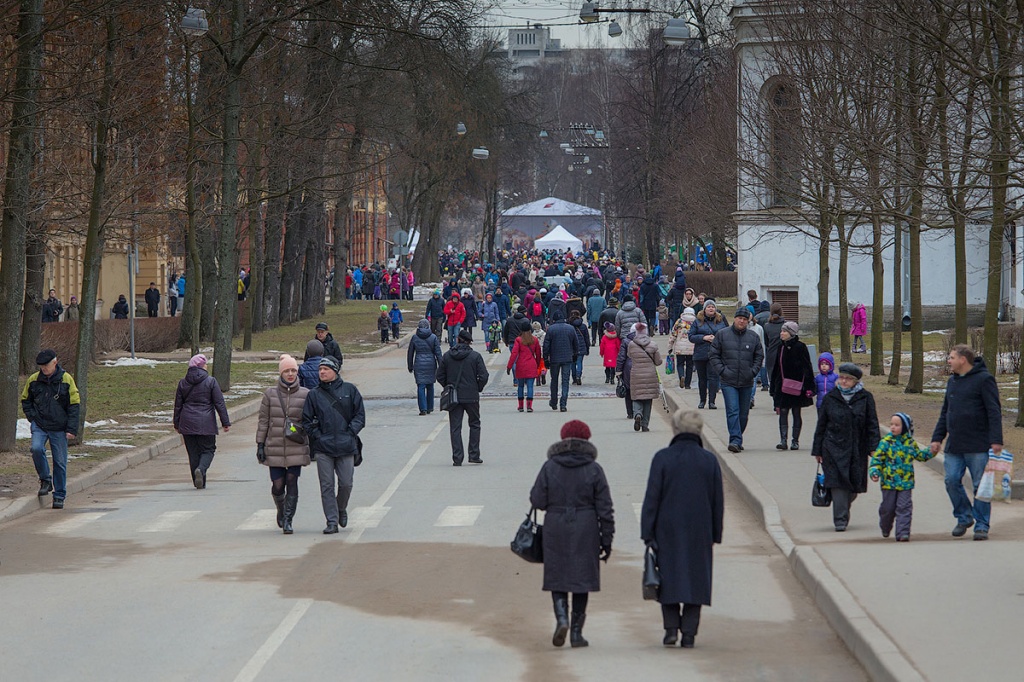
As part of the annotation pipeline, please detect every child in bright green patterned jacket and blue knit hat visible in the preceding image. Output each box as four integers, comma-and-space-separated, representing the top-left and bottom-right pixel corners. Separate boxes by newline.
867, 412, 935, 543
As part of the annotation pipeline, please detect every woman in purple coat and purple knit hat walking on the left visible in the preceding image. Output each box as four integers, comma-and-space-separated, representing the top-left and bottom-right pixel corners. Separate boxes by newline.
173, 353, 231, 491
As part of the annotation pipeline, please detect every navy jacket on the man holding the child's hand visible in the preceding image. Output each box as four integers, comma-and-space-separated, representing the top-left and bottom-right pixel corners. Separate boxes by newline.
932, 357, 1002, 455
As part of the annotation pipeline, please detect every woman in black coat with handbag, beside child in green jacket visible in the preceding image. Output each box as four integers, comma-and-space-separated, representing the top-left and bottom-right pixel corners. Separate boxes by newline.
811, 363, 880, 532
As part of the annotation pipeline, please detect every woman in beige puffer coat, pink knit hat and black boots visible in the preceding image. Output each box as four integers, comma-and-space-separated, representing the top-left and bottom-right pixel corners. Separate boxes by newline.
256, 354, 309, 536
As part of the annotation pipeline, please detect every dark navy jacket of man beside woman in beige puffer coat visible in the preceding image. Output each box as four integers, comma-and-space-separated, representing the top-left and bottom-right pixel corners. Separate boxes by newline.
302, 377, 367, 457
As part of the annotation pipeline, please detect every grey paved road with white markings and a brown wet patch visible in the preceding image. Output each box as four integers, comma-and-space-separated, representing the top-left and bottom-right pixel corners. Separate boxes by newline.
0, 339, 866, 681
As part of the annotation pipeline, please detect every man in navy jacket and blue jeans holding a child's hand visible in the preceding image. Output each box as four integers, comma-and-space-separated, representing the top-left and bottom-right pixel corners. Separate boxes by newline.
931, 344, 1002, 540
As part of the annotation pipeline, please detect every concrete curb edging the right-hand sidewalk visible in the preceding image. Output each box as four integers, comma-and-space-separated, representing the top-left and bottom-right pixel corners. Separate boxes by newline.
666, 389, 925, 682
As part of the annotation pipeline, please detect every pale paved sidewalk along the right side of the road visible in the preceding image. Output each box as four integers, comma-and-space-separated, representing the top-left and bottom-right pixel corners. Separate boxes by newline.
666, 375, 1024, 681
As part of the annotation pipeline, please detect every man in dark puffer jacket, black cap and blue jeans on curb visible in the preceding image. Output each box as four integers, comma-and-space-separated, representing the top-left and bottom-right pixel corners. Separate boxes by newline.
708, 308, 765, 453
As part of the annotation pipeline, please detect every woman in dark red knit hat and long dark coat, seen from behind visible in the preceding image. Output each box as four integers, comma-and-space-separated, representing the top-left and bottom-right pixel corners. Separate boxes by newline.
529, 420, 615, 647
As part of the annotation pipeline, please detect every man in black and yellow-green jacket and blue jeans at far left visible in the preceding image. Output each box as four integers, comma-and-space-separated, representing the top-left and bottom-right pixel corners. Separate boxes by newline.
22, 348, 79, 509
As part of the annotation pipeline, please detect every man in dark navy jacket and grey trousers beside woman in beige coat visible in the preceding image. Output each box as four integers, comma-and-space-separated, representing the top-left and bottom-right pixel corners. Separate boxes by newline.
302, 355, 367, 536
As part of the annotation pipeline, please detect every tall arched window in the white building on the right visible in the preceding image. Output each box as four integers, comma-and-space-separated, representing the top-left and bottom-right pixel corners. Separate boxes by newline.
767, 81, 802, 207
